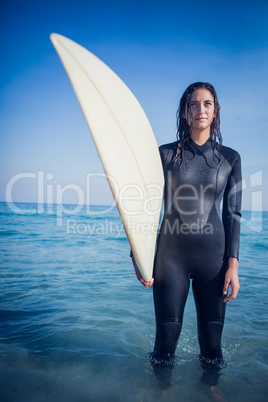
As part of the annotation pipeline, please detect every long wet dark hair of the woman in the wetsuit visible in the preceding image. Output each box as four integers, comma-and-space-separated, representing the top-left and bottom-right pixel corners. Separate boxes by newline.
175, 82, 222, 164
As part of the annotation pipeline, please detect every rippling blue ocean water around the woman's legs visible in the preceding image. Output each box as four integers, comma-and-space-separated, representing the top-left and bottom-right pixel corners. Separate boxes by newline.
0, 203, 268, 402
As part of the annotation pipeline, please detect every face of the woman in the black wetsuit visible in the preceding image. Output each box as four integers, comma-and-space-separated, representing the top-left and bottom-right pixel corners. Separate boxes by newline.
187, 88, 215, 132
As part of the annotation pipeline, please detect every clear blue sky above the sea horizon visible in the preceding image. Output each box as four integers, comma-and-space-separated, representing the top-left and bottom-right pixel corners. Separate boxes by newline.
0, 0, 268, 210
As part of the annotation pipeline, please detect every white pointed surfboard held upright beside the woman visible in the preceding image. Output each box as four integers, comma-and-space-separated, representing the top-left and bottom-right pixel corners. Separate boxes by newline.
50, 34, 164, 281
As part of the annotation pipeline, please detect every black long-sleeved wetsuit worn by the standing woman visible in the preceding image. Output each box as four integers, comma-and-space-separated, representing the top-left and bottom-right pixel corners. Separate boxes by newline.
153, 140, 241, 360
